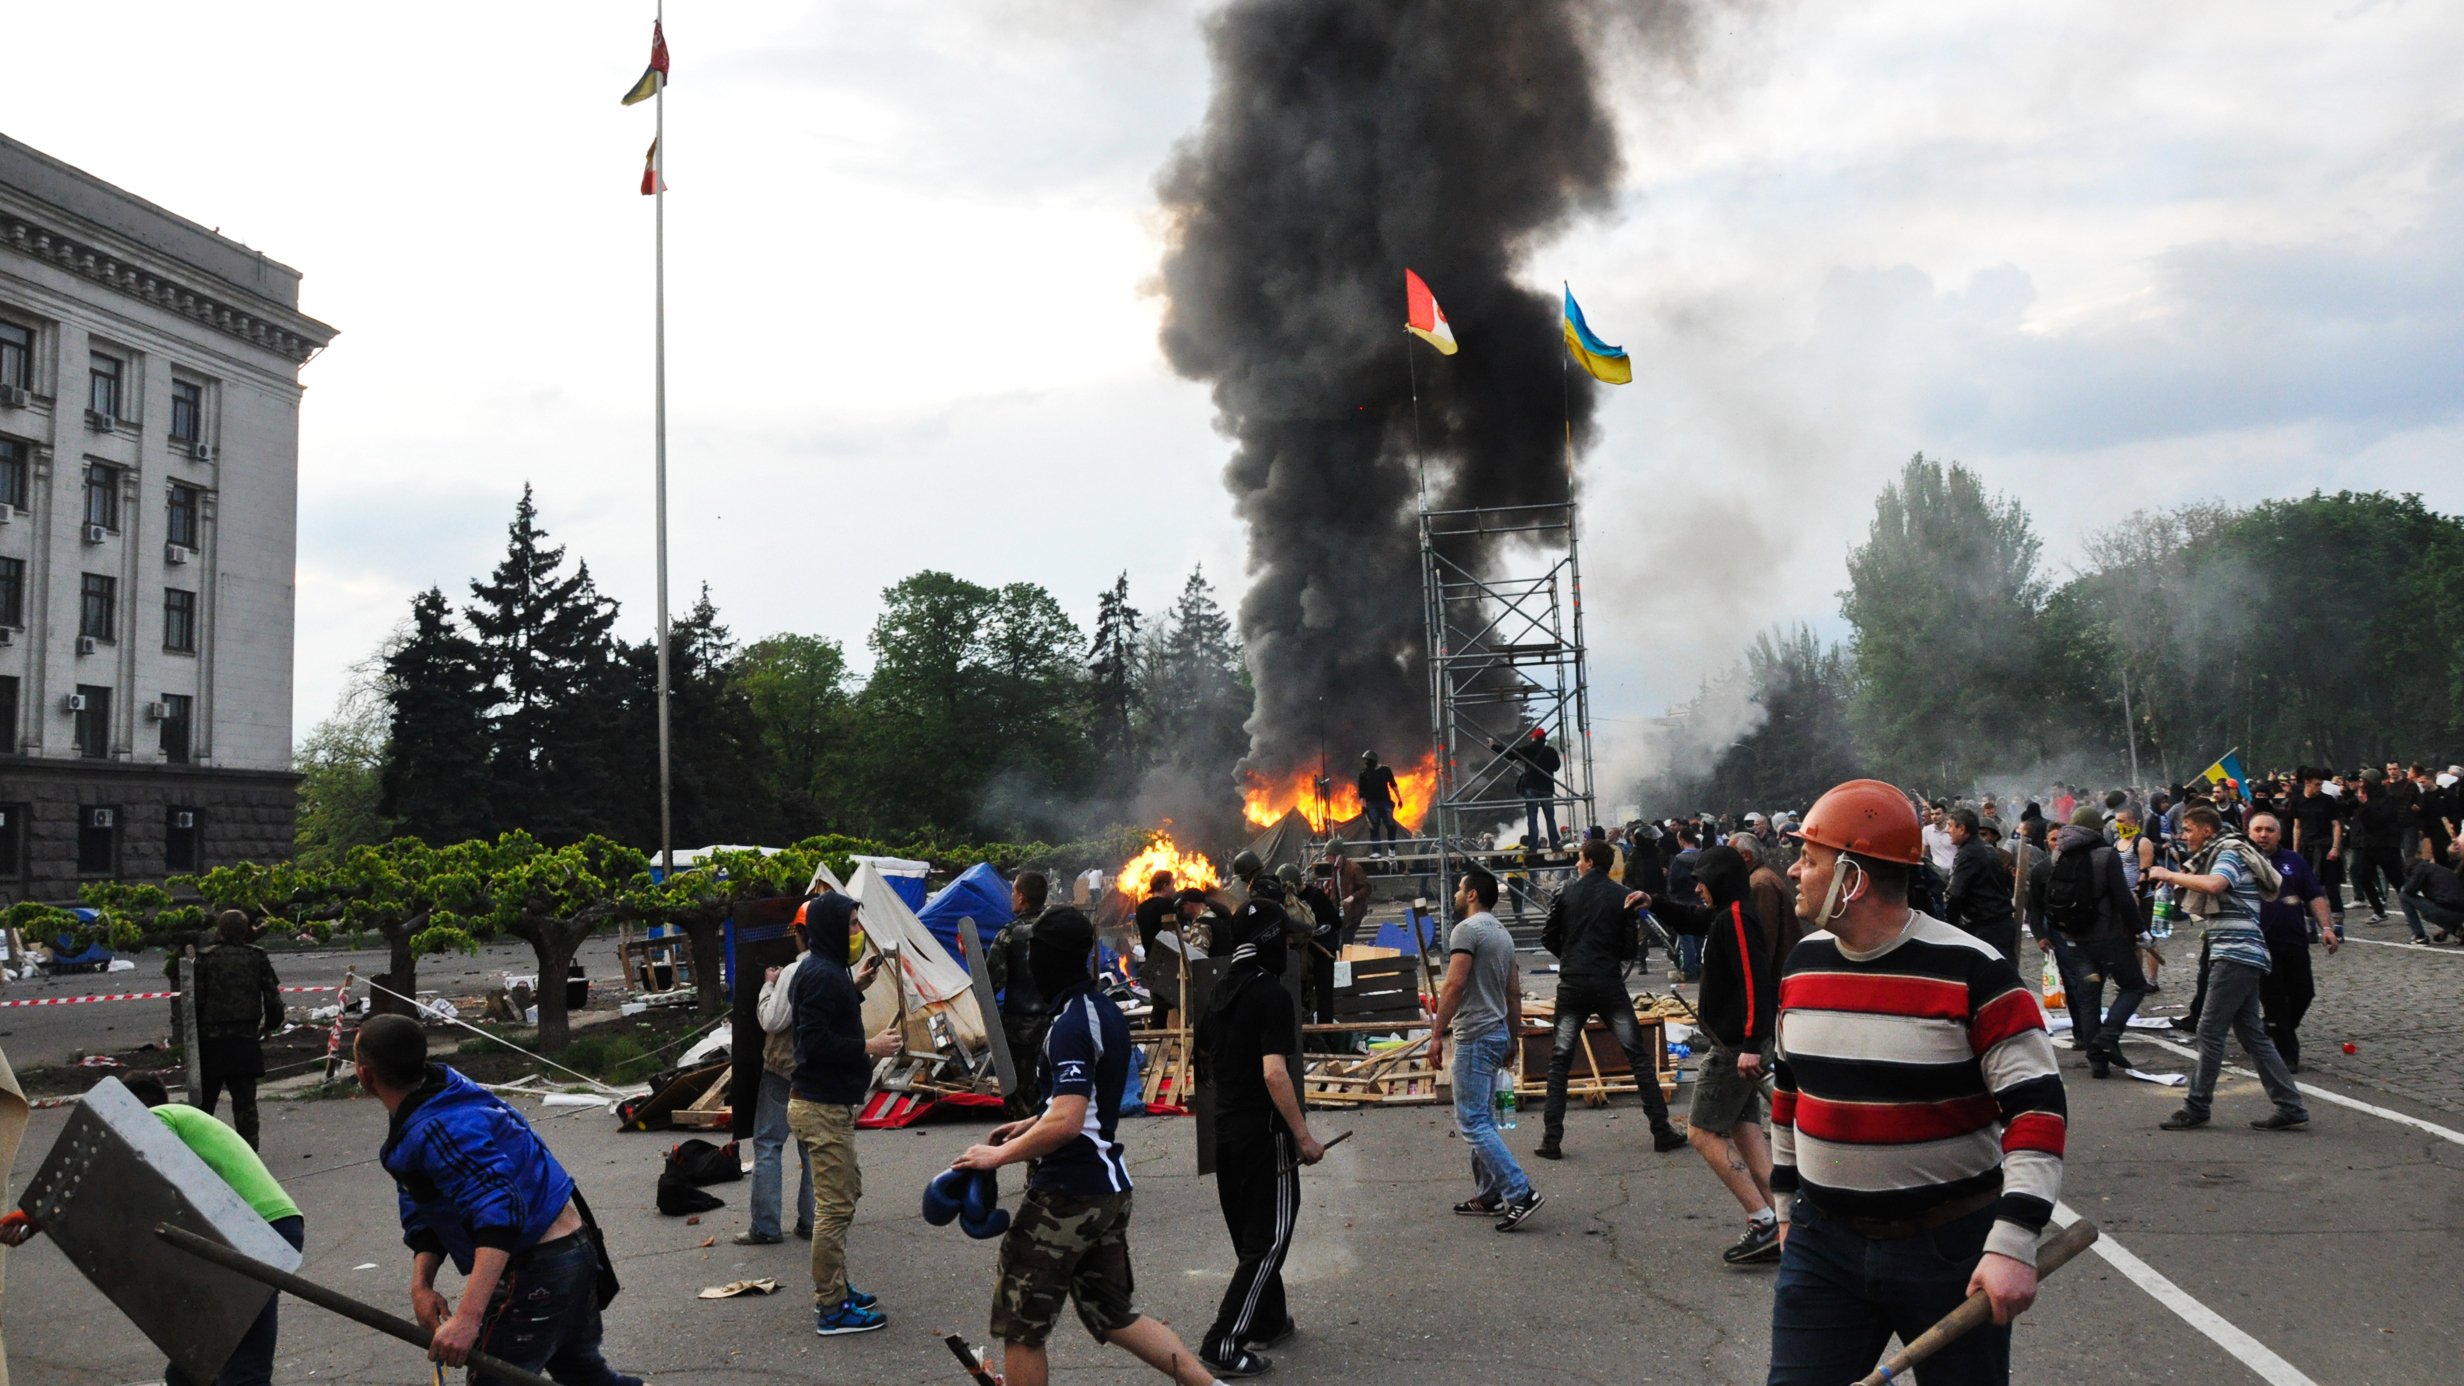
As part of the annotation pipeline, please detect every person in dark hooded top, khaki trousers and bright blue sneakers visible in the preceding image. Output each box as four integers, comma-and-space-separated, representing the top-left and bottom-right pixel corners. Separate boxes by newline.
786, 890, 899, 1337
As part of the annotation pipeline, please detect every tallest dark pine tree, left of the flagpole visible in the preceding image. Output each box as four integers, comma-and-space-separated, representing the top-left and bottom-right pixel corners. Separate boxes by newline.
463, 486, 620, 843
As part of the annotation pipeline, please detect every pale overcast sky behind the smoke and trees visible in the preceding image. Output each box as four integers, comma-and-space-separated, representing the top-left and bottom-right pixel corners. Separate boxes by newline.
0, 0, 2464, 779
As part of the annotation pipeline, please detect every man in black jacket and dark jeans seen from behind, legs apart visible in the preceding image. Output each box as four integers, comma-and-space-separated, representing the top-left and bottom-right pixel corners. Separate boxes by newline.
1538, 841, 1685, 1159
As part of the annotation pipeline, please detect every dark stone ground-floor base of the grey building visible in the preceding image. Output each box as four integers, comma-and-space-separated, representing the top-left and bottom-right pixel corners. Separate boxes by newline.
0, 755, 301, 905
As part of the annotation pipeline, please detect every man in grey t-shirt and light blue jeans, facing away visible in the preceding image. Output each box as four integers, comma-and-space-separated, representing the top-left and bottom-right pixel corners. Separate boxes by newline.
1429, 866, 1540, 1233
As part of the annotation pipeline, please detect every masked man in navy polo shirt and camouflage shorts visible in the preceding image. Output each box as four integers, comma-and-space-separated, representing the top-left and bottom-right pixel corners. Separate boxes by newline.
951, 908, 1215, 1386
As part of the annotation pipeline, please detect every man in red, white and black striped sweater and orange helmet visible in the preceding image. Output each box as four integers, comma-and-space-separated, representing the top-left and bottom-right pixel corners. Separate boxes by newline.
1769, 779, 2065, 1386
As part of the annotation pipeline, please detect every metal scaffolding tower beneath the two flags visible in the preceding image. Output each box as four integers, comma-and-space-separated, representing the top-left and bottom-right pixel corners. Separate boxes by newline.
1419, 501, 1597, 932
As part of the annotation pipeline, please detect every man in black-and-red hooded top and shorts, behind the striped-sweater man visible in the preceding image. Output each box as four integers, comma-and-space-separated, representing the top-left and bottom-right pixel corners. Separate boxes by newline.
1641, 846, 1779, 1265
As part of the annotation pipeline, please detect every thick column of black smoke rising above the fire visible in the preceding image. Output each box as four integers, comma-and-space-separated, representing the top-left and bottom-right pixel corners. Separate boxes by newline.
1161, 0, 1690, 772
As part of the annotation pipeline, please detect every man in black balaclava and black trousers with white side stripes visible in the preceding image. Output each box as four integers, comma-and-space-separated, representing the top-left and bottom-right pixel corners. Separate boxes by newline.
1198, 900, 1326, 1376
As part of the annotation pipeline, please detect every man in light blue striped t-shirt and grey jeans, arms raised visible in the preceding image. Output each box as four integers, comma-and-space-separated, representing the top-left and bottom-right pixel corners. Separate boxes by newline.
2151, 804, 2309, 1132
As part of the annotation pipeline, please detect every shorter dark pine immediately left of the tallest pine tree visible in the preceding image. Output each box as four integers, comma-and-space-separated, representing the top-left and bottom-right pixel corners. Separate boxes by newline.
377, 587, 495, 843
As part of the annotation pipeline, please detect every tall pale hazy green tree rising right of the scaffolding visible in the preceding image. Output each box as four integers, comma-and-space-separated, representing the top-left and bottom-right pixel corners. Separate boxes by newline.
1841, 454, 2045, 787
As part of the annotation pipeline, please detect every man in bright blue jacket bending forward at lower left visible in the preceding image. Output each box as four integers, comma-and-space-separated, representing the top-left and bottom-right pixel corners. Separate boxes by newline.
352, 1001, 641, 1386
